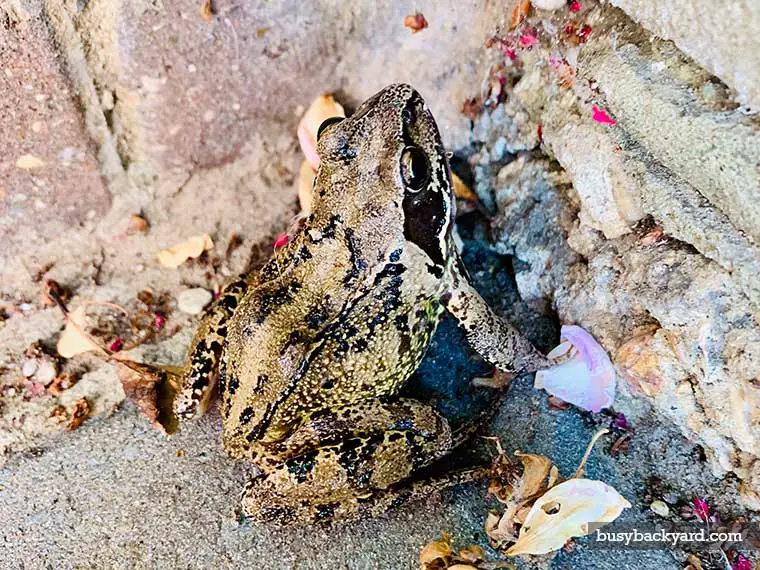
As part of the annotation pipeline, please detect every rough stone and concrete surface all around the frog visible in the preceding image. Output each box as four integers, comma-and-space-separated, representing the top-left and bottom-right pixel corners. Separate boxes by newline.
0, 0, 760, 570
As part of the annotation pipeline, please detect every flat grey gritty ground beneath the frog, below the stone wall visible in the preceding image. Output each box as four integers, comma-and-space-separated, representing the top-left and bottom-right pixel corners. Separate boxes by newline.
0, 224, 733, 570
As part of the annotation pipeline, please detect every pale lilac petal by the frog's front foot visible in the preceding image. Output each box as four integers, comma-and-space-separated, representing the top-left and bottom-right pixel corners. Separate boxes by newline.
534, 325, 616, 413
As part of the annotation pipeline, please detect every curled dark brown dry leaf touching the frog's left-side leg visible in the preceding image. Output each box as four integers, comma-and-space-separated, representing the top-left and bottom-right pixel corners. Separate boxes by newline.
117, 360, 179, 433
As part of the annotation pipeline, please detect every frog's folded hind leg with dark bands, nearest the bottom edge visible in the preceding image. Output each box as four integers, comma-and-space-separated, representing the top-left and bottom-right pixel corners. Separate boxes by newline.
242, 400, 485, 525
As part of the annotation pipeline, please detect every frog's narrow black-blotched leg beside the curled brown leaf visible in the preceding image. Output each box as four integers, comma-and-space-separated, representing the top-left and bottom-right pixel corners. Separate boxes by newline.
174, 276, 249, 420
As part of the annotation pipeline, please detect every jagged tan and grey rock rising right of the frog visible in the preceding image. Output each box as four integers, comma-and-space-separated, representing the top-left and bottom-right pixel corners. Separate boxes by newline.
475, 0, 760, 507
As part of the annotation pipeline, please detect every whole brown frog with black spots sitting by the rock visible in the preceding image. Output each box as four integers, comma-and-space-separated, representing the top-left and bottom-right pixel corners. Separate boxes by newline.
175, 85, 546, 524
